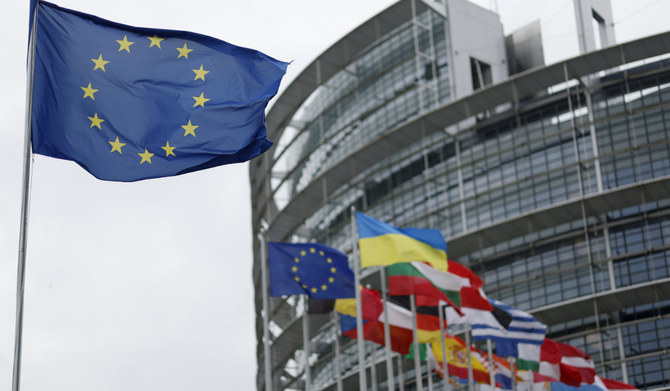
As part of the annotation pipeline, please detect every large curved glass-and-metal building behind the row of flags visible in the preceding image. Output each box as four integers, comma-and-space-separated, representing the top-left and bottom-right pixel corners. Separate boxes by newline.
250, 0, 670, 391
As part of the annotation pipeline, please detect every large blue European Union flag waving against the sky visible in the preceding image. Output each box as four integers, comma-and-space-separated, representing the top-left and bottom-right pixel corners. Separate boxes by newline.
32, 2, 288, 181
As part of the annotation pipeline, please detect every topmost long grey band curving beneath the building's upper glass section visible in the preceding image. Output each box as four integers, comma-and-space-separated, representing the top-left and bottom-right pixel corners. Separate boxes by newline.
266, 32, 670, 242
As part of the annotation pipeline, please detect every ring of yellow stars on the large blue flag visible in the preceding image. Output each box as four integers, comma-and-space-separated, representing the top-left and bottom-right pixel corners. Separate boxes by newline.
80, 34, 213, 167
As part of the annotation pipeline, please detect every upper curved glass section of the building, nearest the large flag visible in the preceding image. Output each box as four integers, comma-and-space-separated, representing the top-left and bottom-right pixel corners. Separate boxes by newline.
272, 12, 449, 213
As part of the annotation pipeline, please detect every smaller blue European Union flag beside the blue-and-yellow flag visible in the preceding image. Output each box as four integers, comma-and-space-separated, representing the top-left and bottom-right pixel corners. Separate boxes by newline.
268, 242, 356, 299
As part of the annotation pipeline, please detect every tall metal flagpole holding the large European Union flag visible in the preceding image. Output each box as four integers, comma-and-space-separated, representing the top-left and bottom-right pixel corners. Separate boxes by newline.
12, 4, 39, 391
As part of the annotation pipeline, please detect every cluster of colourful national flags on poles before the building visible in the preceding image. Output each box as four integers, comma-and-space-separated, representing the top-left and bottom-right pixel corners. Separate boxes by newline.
259, 208, 636, 391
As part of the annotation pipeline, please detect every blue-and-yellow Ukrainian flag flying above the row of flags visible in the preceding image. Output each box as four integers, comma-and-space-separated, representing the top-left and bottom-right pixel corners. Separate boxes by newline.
356, 212, 447, 271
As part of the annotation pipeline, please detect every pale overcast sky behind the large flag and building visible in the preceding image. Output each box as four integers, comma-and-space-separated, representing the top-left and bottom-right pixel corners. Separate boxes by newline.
0, 0, 670, 391
